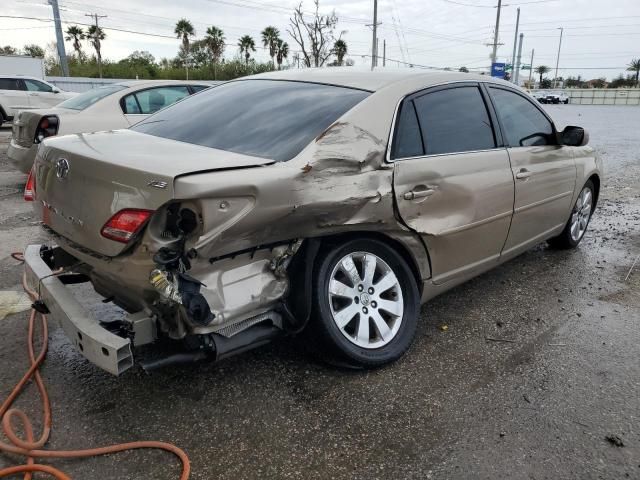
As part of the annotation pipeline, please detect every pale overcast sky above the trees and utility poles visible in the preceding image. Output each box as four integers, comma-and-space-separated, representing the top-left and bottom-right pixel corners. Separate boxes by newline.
0, 0, 640, 79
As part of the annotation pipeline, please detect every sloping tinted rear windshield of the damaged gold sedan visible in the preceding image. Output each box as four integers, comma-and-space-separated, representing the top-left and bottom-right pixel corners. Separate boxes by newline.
132, 80, 370, 161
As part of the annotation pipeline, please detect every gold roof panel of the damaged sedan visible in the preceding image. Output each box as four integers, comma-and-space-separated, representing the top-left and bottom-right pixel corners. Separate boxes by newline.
245, 67, 514, 91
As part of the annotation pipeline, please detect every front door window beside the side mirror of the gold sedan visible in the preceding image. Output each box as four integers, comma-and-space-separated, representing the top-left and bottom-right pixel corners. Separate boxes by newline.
489, 87, 555, 147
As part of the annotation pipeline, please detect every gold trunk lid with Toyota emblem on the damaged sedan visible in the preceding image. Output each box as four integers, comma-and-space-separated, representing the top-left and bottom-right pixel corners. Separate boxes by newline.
34, 130, 273, 256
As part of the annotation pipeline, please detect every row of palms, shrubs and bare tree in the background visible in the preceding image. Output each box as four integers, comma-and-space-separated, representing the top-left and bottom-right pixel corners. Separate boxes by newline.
0, 0, 353, 80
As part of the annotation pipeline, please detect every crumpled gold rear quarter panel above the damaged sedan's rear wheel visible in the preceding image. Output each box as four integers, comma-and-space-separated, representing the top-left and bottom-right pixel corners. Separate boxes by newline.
168, 99, 430, 323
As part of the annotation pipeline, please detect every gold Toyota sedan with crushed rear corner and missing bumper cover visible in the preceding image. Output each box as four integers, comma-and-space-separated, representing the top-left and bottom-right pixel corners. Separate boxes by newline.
25, 68, 601, 374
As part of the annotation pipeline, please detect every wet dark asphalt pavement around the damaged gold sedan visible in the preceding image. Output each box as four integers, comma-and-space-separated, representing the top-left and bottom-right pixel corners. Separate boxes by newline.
0, 105, 640, 480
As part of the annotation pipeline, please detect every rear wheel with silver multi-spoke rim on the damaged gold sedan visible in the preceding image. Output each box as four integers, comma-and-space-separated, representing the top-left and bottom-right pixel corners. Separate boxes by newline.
307, 239, 420, 368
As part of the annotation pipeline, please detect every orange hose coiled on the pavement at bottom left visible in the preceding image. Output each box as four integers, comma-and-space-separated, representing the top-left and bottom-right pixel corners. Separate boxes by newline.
0, 254, 191, 480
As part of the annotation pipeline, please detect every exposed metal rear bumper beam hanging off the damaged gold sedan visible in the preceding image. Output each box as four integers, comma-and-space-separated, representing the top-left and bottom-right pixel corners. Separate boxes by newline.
24, 245, 133, 375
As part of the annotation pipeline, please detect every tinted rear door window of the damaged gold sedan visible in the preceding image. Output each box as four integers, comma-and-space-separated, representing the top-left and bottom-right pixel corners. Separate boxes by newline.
413, 86, 496, 155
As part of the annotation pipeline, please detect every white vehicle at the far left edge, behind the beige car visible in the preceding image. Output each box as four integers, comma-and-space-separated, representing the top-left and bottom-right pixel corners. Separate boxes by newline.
0, 75, 77, 125
